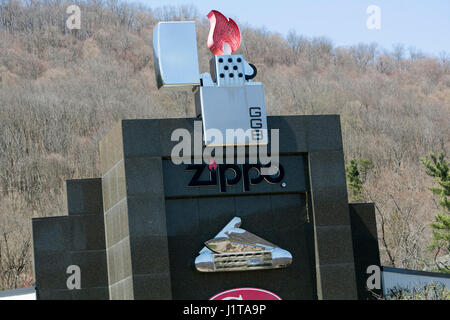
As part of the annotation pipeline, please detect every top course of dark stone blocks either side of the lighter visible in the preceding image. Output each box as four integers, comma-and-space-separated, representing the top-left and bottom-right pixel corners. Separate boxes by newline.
119, 115, 342, 157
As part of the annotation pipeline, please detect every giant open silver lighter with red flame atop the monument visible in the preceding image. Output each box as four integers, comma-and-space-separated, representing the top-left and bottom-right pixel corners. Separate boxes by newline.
153, 10, 268, 147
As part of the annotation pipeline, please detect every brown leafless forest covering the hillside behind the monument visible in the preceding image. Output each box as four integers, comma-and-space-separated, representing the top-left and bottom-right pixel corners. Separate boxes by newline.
0, 0, 450, 290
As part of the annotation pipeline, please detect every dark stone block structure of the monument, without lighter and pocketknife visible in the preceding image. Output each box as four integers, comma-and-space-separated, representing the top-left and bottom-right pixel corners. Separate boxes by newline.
33, 115, 372, 299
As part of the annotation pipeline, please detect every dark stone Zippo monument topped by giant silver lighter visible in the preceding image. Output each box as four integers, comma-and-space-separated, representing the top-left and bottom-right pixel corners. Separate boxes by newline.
32, 11, 380, 300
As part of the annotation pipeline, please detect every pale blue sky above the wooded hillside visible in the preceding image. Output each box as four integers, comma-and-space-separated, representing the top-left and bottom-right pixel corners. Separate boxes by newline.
126, 0, 450, 56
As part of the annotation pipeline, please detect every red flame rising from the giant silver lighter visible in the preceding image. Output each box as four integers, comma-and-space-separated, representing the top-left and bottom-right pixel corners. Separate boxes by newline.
207, 10, 241, 56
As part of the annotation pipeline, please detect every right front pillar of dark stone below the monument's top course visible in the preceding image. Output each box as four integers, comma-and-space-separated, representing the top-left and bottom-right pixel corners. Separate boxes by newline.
308, 146, 357, 300
